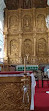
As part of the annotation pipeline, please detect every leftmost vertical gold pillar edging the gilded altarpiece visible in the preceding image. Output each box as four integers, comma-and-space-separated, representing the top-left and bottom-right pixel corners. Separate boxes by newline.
4, 9, 8, 63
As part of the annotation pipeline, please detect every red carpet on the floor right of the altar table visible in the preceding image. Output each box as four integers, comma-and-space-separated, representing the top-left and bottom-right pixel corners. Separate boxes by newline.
34, 81, 49, 111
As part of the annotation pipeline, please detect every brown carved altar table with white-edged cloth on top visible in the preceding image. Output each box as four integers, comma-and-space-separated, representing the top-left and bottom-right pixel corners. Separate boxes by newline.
0, 73, 31, 111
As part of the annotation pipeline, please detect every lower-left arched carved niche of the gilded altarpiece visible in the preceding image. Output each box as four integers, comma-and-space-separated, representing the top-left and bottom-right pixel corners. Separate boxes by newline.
9, 39, 19, 64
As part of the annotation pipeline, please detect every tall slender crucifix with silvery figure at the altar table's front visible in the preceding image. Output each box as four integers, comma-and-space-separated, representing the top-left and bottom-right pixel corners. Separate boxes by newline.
21, 57, 29, 111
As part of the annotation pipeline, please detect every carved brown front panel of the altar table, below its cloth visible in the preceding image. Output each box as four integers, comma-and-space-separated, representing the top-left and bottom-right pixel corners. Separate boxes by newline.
0, 77, 31, 111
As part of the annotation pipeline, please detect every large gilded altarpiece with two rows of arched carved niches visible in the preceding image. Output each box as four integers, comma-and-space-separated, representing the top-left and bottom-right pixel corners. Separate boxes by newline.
4, 8, 49, 64
